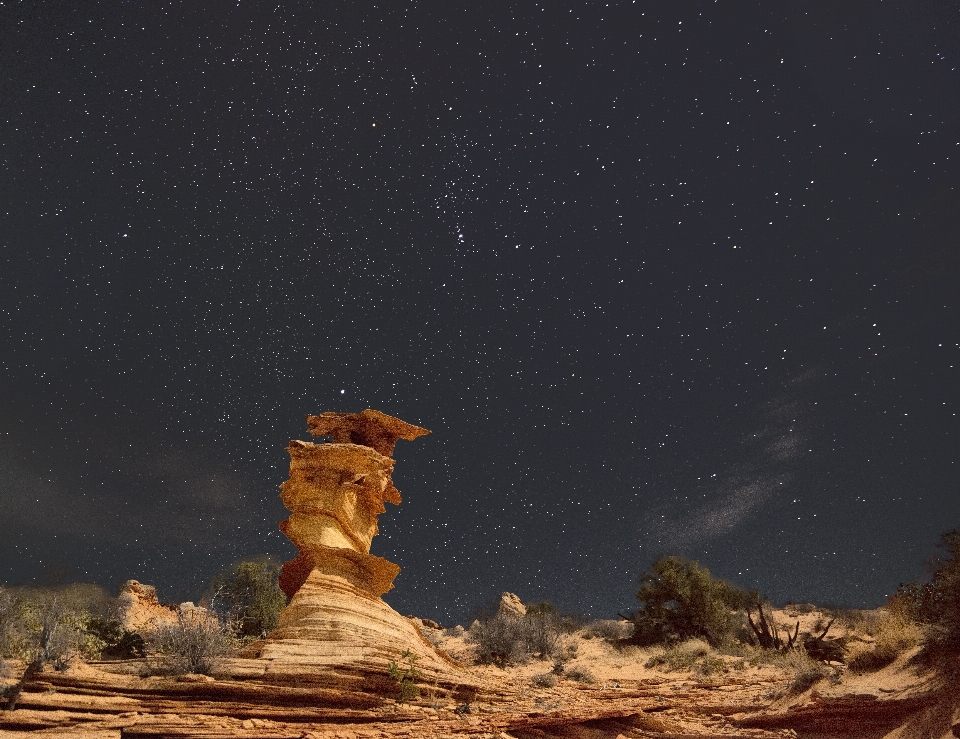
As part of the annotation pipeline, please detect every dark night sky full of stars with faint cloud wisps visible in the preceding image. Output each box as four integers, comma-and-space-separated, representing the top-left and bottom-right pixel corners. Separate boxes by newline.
0, 0, 960, 625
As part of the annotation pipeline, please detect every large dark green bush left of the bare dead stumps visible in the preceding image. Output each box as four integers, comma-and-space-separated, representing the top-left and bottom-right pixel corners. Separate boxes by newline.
633, 557, 749, 645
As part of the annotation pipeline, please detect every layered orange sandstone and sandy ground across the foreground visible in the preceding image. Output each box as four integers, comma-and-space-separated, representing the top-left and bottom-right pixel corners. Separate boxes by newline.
0, 608, 960, 739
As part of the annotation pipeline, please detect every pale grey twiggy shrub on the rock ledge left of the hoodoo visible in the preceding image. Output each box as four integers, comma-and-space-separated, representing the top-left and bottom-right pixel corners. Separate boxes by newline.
146, 612, 235, 675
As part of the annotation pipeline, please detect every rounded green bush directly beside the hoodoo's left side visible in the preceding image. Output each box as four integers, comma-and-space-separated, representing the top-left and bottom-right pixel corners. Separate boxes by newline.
201, 560, 287, 639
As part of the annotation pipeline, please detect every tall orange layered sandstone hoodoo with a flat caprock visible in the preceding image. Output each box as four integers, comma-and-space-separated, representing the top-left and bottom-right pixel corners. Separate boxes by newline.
257, 410, 470, 687
